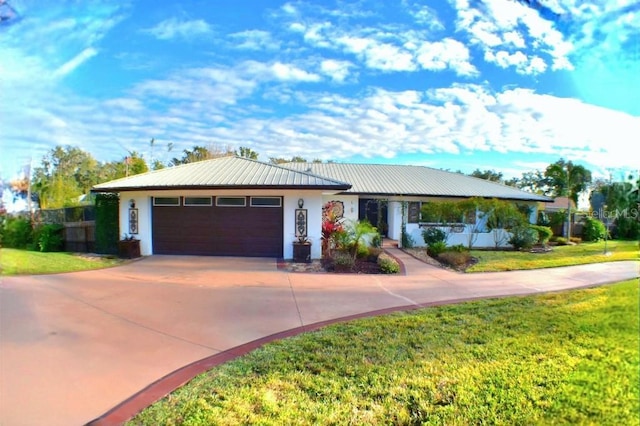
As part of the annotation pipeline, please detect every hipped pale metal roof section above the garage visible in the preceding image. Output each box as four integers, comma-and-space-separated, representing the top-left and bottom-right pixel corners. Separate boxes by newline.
92, 156, 351, 192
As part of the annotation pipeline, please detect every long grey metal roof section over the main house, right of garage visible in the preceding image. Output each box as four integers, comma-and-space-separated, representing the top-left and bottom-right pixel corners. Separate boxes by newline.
284, 163, 553, 201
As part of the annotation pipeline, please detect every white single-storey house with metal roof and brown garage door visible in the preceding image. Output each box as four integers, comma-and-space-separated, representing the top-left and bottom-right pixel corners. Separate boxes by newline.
92, 156, 551, 259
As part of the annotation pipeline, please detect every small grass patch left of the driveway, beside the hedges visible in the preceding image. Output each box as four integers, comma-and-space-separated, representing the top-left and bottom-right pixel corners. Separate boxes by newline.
0, 248, 122, 276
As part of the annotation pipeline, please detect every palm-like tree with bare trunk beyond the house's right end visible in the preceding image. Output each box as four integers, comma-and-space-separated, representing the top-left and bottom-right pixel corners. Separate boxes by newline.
544, 159, 591, 238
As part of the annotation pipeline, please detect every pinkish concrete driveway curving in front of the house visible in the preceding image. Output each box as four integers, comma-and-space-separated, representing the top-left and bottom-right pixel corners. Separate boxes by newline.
0, 248, 639, 426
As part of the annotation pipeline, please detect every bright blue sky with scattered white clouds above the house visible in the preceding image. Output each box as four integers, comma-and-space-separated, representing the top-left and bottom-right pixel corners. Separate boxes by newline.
0, 0, 640, 179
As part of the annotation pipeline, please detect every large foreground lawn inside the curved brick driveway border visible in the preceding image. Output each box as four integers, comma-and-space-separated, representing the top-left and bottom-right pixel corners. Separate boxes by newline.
129, 281, 640, 425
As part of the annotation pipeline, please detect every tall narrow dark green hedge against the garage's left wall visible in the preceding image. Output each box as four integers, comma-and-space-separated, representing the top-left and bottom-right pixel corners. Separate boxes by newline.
96, 193, 120, 254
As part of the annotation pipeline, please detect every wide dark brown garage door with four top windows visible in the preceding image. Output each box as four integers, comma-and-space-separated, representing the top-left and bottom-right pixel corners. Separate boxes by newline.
152, 197, 283, 257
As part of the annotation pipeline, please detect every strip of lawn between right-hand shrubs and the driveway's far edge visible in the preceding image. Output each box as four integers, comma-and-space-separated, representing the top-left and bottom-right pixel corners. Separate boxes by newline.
466, 241, 640, 272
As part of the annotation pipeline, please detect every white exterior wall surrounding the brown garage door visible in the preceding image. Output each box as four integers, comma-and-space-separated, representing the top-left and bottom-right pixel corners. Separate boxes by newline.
119, 190, 330, 259
